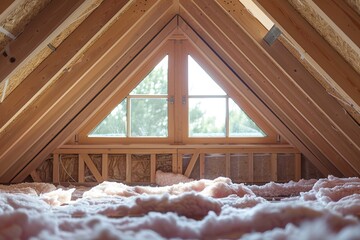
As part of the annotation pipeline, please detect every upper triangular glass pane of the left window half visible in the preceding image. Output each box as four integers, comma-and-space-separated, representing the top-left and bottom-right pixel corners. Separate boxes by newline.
130, 56, 168, 95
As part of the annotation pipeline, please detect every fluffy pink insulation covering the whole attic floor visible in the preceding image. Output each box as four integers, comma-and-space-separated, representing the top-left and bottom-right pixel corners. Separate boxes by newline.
0, 171, 360, 240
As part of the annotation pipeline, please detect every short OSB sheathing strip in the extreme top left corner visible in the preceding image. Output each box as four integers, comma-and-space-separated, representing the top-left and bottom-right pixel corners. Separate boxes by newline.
0, 0, 51, 51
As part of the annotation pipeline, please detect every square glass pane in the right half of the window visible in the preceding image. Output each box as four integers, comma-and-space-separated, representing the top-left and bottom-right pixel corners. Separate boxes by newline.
189, 98, 226, 137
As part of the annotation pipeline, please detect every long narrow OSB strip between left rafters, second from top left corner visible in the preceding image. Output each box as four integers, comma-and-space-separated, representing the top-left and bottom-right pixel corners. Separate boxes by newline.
0, 0, 103, 98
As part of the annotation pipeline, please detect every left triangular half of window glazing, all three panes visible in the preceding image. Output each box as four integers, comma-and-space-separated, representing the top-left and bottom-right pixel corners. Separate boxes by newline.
89, 56, 168, 137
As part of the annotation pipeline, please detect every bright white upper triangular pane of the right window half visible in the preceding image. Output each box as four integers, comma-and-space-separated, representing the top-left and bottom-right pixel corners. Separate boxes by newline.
188, 55, 226, 95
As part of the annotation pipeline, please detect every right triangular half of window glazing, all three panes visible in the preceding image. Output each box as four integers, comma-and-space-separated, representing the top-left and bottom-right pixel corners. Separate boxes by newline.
188, 55, 266, 137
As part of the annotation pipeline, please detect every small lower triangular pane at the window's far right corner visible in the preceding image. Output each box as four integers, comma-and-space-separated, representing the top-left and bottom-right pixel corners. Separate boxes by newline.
229, 99, 266, 137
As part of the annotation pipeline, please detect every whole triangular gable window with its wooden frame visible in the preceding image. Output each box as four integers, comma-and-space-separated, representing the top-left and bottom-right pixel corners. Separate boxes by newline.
82, 37, 275, 144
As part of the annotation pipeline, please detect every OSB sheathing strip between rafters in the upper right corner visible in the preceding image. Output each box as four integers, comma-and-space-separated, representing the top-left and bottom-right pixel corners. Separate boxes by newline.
289, 0, 360, 73
